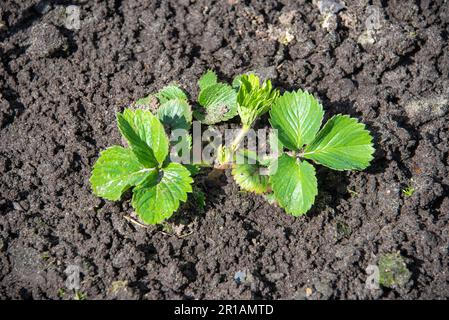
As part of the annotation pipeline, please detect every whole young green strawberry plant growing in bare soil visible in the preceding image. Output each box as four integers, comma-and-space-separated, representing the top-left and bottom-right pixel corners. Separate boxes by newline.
90, 71, 374, 224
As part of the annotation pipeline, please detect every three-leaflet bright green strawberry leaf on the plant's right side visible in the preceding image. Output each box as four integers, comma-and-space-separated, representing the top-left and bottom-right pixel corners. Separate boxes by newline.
270, 90, 374, 216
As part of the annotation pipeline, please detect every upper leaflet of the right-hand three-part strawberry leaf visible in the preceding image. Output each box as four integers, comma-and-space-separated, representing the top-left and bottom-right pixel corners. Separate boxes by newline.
270, 90, 324, 150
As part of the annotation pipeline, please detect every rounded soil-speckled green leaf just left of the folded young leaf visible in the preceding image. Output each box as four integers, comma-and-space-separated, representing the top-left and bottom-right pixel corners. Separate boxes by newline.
195, 83, 237, 125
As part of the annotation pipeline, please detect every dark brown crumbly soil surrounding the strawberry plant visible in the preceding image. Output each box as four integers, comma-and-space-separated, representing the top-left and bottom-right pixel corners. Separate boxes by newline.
0, 0, 449, 299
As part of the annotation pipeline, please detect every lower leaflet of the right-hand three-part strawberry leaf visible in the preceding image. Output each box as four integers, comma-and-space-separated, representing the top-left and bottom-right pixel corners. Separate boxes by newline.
270, 154, 318, 216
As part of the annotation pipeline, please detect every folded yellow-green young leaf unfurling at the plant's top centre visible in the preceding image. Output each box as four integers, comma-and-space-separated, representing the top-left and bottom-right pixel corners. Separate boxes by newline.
237, 74, 279, 127
